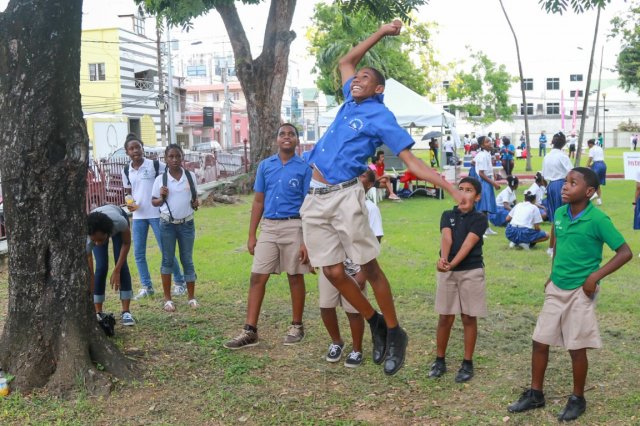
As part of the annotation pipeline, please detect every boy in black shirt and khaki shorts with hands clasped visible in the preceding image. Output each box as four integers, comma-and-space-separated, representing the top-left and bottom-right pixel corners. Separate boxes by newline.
429, 177, 488, 383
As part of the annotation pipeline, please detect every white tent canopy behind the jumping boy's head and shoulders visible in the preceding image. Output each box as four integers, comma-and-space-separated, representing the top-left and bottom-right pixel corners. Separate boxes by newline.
319, 78, 456, 127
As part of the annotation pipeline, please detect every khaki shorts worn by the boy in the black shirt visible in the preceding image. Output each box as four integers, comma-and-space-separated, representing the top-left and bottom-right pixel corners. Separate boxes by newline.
436, 268, 487, 317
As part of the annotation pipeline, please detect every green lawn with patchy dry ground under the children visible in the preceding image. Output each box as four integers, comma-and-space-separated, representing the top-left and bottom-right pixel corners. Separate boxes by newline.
0, 178, 640, 425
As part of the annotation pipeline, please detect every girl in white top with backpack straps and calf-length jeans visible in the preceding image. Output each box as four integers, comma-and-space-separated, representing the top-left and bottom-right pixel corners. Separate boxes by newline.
151, 144, 199, 312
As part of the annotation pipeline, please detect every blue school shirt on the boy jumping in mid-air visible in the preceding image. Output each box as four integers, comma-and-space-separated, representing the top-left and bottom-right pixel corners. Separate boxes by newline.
304, 77, 414, 185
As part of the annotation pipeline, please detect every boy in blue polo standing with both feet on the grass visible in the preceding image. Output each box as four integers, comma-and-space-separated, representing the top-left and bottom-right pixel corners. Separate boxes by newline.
224, 123, 311, 349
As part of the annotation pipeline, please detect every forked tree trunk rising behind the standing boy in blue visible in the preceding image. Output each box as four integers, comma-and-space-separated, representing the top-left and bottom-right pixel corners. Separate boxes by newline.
216, 0, 296, 168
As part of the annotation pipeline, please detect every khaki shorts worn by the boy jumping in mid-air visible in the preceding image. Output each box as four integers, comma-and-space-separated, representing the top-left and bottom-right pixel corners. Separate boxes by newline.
300, 183, 380, 267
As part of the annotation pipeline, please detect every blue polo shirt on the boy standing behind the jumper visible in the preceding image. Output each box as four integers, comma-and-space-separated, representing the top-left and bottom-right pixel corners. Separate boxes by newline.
253, 154, 311, 219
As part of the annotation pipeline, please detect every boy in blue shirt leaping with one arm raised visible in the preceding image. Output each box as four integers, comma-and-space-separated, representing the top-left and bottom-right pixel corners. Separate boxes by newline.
300, 20, 462, 375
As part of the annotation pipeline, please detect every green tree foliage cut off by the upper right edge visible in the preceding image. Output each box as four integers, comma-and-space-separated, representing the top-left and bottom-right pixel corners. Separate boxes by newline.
611, 0, 640, 94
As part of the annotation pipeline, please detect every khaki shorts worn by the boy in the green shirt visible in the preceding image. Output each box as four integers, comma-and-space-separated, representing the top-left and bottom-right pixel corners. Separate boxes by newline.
532, 282, 602, 350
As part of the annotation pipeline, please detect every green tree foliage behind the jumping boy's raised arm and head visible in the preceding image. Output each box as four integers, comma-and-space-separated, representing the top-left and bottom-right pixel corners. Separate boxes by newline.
307, 4, 443, 99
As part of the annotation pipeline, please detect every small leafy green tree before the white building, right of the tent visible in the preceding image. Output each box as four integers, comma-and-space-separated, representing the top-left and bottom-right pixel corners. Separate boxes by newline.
447, 52, 518, 124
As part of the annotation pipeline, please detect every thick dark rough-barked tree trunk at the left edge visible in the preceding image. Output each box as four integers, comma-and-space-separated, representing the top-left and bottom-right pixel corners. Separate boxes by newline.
0, 0, 132, 394
